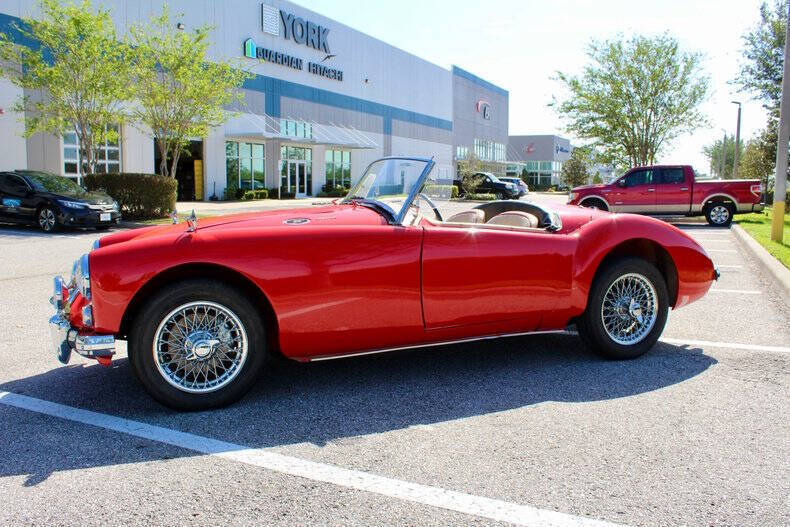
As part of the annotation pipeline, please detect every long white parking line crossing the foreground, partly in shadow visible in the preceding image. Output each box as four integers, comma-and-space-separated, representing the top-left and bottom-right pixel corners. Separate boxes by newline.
0, 391, 615, 527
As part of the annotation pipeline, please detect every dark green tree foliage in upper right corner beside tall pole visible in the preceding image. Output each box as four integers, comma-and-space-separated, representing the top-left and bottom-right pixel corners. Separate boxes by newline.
733, 0, 787, 119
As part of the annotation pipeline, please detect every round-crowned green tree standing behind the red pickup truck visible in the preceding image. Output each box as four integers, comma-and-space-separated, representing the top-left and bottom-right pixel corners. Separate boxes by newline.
552, 34, 709, 166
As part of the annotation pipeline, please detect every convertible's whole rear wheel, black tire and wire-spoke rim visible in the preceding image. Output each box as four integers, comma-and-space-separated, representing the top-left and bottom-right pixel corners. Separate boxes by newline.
577, 257, 669, 359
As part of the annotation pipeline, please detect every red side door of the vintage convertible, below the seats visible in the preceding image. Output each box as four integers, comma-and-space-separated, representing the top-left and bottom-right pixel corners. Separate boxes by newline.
422, 225, 575, 335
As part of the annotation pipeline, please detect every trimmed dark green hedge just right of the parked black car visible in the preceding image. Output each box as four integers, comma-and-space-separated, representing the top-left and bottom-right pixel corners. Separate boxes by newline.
83, 174, 178, 219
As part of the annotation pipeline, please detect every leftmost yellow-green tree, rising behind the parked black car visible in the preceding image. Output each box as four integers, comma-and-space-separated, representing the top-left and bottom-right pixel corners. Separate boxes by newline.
0, 0, 129, 179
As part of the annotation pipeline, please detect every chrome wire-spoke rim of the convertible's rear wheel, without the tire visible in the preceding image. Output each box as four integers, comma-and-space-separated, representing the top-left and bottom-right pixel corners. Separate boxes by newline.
601, 273, 658, 346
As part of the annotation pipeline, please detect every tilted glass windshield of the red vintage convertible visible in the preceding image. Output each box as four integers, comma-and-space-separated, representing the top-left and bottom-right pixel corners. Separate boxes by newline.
343, 158, 433, 221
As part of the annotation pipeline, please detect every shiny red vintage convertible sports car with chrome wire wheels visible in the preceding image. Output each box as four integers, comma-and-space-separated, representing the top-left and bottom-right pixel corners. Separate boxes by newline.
50, 158, 718, 410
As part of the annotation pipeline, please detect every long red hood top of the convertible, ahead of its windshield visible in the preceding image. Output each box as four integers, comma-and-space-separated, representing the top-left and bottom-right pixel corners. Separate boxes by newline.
101, 204, 386, 247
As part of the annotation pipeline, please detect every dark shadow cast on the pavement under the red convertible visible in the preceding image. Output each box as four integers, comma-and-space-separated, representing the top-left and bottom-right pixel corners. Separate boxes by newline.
0, 334, 716, 483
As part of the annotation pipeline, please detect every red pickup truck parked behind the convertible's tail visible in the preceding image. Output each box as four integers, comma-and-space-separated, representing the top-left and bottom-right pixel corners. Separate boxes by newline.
568, 165, 764, 227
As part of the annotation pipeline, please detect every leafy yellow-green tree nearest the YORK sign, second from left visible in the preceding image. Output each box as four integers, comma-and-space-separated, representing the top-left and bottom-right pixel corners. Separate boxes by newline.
129, 6, 250, 177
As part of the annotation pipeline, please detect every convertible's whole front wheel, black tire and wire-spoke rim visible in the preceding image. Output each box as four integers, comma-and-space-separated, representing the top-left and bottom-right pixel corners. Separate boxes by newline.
129, 280, 266, 410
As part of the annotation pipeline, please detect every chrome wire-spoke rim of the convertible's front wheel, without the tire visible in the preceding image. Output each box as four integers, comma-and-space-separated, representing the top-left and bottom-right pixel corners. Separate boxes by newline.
153, 302, 247, 393
